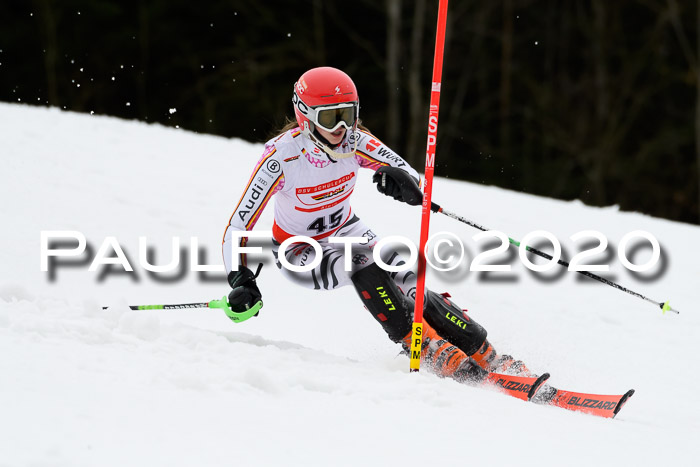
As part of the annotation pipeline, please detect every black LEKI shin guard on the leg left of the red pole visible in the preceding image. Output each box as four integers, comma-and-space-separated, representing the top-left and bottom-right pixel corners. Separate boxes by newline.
352, 264, 413, 342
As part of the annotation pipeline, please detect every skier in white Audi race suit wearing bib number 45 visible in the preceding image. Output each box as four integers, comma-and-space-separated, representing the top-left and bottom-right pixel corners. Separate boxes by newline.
223, 67, 530, 382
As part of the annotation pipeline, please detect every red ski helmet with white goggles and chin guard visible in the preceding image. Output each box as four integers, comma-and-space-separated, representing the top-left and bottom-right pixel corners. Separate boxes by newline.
292, 67, 360, 157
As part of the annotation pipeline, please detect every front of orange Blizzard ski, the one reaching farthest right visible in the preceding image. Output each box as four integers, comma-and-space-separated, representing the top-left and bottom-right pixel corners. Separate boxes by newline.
531, 386, 634, 418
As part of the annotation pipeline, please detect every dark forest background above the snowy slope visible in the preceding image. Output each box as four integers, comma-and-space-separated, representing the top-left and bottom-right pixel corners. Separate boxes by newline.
0, 0, 700, 223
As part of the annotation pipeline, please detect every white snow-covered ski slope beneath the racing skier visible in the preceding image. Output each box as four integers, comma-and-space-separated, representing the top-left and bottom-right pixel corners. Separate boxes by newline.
0, 104, 700, 467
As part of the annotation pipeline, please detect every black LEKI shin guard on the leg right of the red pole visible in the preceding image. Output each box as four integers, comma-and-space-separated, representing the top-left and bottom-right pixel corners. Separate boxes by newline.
423, 290, 486, 356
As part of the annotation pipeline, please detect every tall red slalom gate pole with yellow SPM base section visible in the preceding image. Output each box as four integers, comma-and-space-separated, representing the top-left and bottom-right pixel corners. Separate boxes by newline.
410, 0, 447, 371
